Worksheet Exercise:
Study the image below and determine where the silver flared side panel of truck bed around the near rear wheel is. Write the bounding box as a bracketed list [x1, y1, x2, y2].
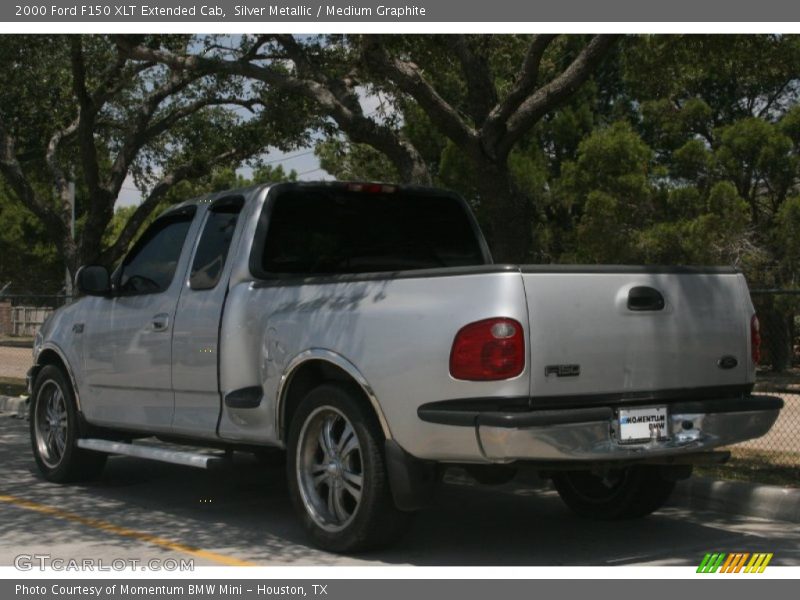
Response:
[220, 271, 529, 460]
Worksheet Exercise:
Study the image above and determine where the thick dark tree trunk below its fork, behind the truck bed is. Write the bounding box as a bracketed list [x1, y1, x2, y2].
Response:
[477, 164, 534, 263]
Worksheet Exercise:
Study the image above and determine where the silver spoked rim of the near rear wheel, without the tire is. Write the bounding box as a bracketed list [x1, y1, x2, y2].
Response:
[295, 406, 364, 531]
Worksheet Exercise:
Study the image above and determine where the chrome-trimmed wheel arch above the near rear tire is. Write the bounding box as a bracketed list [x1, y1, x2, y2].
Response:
[275, 348, 392, 442]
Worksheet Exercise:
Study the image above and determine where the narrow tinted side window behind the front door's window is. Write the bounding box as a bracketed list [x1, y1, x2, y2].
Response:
[189, 198, 242, 290]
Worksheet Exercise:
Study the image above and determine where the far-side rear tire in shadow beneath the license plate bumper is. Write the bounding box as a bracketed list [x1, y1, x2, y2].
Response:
[553, 465, 675, 520]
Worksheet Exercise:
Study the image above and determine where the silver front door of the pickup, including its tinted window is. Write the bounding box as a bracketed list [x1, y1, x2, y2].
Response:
[83, 206, 196, 432]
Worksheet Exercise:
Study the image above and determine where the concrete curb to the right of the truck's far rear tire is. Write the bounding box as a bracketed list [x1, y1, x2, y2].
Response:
[670, 477, 800, 523]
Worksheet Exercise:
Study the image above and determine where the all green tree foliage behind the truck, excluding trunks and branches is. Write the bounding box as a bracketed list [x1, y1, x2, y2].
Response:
[0, 35, 800, 308]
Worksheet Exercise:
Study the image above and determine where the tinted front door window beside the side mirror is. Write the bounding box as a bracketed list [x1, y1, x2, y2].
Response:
[119, 212, 194, 294]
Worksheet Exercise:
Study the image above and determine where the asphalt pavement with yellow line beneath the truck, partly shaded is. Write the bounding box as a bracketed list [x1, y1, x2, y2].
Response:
[0, 415, 800, 566]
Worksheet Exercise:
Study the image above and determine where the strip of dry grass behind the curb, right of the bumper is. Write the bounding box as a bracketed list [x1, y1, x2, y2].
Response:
[694, 448, 800, 487]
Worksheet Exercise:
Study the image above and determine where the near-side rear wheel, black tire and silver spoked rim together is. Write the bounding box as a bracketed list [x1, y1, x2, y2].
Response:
[287, 383, 409, 553]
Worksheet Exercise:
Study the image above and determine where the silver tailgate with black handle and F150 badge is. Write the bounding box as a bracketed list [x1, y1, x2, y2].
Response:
[522, 267, 754, 406]
